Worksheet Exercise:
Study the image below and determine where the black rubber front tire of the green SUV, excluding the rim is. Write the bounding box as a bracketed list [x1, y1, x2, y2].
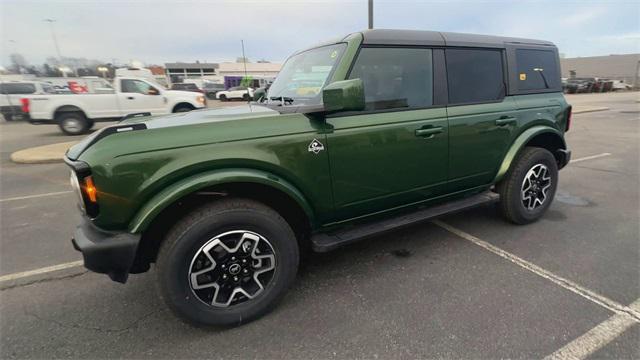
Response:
[156, 198, 299, 326]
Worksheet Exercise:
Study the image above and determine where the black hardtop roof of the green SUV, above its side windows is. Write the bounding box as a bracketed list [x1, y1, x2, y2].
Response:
[362, 29, 555, 48]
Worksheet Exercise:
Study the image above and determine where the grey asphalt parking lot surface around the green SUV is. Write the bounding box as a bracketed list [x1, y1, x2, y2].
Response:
[0, 93, 640, 359]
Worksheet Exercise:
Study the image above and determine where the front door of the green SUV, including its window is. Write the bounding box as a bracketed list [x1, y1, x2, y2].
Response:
[326, 47, 448, 221]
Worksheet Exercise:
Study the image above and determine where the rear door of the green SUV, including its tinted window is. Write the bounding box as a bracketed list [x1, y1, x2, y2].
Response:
[445, 48, 518, 192]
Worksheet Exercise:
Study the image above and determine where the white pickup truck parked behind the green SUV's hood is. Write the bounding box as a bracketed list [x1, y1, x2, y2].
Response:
[26, 77, 206, 135]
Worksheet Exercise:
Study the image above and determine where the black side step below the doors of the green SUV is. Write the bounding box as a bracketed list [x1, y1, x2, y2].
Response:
[311, 191, 500, 252]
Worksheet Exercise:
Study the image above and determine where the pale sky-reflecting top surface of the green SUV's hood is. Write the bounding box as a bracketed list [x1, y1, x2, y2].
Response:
[66, 104, 279, 160]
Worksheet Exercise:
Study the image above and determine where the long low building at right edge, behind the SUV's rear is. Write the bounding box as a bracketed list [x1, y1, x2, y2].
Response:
[560, 54, 640, 87]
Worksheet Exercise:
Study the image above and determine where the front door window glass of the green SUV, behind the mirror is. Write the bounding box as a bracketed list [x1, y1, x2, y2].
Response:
[349, 48, 433, 110]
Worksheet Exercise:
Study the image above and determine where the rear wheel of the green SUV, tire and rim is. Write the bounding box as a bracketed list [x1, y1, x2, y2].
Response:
[497, 147, 558, 224]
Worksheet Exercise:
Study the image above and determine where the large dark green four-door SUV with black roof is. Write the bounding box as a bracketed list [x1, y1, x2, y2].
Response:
[66, 30, 571, 325]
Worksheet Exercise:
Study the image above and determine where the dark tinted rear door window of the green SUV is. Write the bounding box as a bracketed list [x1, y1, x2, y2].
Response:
[445, 49, 505, 104]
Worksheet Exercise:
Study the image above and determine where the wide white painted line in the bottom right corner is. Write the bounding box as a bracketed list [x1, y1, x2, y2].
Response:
[544, 299, 640, 360]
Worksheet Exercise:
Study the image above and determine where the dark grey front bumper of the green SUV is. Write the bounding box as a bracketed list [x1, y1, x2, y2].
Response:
[71, 217, 140, 283]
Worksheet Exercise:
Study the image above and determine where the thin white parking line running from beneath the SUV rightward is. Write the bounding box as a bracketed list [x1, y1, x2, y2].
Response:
[433, 220, 640, 322]
